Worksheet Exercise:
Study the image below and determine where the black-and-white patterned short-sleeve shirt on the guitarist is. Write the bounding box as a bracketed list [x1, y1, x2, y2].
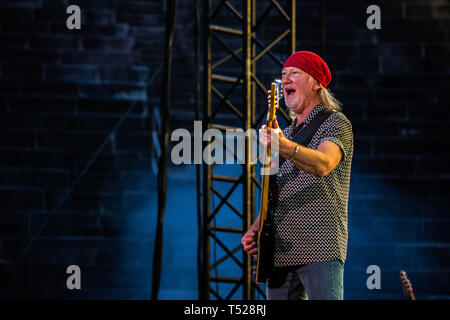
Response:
[273, 105, 353, 267]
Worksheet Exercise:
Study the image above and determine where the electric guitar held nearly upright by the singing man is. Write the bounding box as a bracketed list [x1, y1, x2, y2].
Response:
[256, 80, 281, 283]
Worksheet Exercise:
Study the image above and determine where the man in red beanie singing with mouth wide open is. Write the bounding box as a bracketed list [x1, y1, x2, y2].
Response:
[241, 51, 353, 300]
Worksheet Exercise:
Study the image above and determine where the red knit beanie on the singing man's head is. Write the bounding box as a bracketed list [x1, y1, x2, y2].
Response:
[283, 51, 331, 88]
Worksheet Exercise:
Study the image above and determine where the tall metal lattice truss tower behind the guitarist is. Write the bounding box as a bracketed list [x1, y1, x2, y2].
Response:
[198, 0, 295, 300]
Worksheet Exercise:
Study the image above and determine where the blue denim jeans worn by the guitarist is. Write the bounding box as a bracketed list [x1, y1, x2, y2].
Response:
[267, 260, 344, 300]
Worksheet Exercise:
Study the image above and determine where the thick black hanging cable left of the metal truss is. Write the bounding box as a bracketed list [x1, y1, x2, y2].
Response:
[152, 0, 176, 300]
